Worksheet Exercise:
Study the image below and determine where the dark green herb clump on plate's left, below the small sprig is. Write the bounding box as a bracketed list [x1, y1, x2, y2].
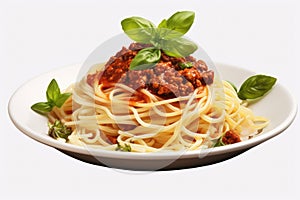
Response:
[48, 120, 72, 141]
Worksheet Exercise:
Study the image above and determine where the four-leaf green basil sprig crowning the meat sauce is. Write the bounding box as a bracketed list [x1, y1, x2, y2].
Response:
[121, 11, 198, 70]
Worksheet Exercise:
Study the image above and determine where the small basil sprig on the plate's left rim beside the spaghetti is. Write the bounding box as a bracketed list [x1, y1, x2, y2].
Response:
[31, 79, 71, 115]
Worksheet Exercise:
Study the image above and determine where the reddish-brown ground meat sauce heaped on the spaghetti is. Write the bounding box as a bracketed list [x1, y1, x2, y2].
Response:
[87, 43, 214, 99]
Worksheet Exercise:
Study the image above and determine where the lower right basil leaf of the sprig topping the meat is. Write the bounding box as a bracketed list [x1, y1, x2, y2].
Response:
[162, 38, 198, 57]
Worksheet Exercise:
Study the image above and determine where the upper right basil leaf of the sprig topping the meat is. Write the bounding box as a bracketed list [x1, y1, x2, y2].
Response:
[158, 11, 195, 40]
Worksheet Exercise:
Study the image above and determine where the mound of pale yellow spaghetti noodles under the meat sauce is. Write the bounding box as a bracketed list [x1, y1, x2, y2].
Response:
[49, 67, 268, 152]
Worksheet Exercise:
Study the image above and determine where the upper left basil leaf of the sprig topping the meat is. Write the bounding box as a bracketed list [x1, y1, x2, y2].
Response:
[121, 17, 156, 43]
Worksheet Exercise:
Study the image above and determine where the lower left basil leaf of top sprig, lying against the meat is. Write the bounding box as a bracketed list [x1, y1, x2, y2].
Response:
[130, 47, 161, 70]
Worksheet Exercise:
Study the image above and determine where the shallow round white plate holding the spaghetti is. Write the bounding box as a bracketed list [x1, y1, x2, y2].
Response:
[8, 64, 297, 170]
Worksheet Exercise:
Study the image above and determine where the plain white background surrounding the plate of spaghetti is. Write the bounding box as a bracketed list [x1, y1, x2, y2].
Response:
[0, 0, 300, 200]
